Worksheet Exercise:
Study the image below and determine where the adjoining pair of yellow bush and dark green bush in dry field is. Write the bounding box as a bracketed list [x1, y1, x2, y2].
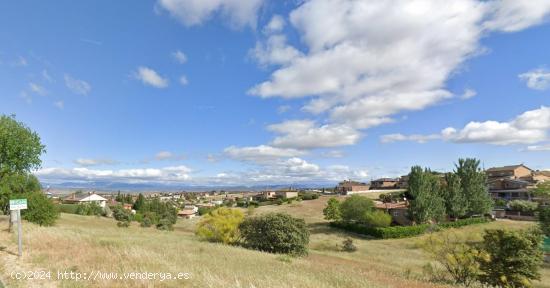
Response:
[196, 207, 309, 255]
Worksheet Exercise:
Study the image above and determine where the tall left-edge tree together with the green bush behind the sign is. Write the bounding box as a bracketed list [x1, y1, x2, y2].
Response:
[0, 115, 59, 230]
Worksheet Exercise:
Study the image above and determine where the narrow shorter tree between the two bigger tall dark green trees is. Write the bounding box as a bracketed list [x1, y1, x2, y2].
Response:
[442, 173, 468, 219]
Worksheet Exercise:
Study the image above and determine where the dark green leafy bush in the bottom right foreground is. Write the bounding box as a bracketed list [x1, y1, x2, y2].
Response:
[478, 229, 543, 287]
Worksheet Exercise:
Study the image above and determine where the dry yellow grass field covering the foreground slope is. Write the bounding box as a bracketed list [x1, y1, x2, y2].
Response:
[0, 197, 550, 287]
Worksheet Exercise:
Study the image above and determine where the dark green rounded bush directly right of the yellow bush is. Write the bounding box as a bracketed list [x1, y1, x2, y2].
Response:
[239, 213, 309, 255]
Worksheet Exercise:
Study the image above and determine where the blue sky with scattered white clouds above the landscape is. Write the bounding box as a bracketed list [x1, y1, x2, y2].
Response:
[0, 0, 550, 185]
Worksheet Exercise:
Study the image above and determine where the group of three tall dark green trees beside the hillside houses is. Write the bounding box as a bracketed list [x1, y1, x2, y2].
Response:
[406, 158, 493, 224]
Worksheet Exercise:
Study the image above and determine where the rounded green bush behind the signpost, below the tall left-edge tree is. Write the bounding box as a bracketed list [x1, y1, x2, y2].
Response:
[13, 191, 59, 226]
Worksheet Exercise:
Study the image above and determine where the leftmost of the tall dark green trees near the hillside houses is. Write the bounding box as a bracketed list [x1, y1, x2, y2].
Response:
[407, 166, 445, 224]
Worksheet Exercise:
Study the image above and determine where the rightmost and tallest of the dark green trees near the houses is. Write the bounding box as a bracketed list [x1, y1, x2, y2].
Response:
[455, 158, 493, 215]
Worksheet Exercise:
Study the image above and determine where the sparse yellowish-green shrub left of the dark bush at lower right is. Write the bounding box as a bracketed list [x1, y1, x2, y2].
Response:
[422, 232, 479, 287]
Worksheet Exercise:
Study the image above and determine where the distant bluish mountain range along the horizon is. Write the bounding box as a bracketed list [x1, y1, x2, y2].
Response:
[42, 181, 336, 192]
